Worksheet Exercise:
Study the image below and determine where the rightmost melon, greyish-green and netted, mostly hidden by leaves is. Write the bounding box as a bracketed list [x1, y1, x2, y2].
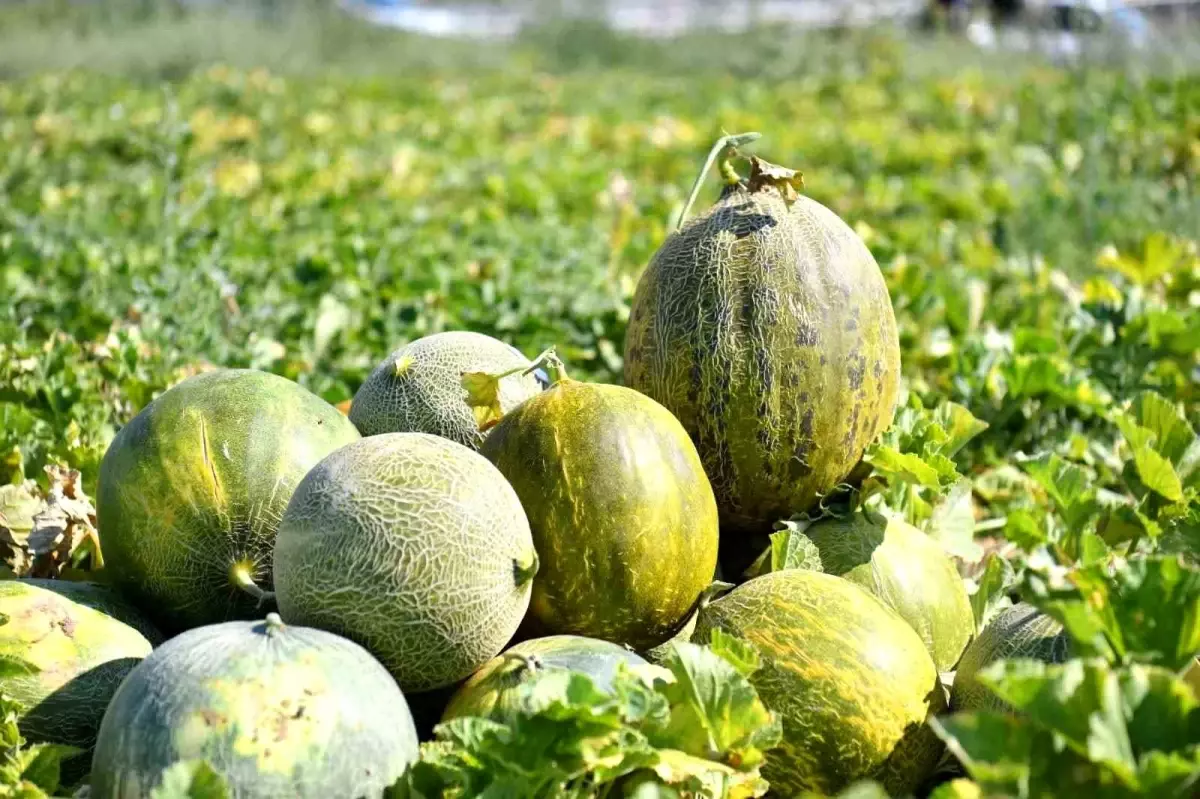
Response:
[950, 602, 1070, 711]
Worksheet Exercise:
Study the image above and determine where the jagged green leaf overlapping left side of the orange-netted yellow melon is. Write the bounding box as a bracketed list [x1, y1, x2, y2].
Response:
[650, 642, 781, 768]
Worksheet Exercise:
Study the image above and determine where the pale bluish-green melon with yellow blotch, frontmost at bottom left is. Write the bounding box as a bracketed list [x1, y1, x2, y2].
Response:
[90, 613, 418, 799]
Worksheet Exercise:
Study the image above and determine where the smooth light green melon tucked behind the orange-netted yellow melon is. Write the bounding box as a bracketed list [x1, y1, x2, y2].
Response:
[804, 512, 974, 672]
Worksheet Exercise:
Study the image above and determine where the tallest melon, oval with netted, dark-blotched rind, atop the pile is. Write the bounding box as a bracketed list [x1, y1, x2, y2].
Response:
[624, 188, 900, 535]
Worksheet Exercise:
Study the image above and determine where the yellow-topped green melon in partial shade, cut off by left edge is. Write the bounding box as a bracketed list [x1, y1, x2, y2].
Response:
[0, 578, 162, 750]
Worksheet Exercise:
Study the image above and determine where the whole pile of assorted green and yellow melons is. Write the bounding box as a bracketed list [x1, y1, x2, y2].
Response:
[0, 133, 993, 799]
